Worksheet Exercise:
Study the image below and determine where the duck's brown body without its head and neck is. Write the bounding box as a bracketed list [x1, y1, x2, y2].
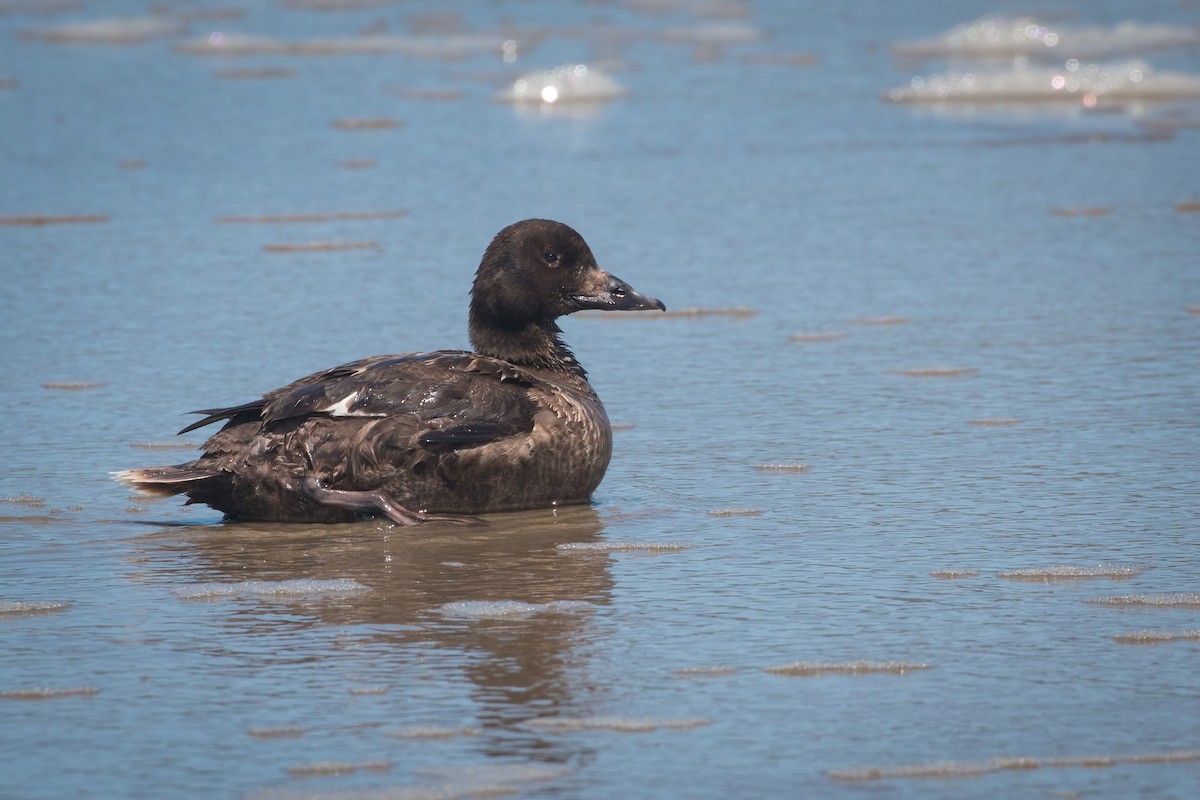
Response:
[142, 350, 612, 522]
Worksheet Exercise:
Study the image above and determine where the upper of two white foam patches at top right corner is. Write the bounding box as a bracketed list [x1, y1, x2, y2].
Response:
[892, 17, 1200, 59]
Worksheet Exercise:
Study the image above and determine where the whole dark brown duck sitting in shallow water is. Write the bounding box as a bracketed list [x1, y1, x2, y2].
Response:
[113, 219, 666, 525]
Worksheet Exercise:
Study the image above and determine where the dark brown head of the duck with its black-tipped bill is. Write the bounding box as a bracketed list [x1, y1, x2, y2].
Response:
[470, 219, 666, 331]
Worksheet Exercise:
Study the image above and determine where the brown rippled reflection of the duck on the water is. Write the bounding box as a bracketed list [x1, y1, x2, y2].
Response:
[138, 506, 612, 756]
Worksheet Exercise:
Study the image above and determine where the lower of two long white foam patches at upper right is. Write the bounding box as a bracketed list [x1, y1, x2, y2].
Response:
[884, 59, 1200, 108]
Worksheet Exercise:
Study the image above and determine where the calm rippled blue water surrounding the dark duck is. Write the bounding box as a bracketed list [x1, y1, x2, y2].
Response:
[0, 0, 1200, 799]
